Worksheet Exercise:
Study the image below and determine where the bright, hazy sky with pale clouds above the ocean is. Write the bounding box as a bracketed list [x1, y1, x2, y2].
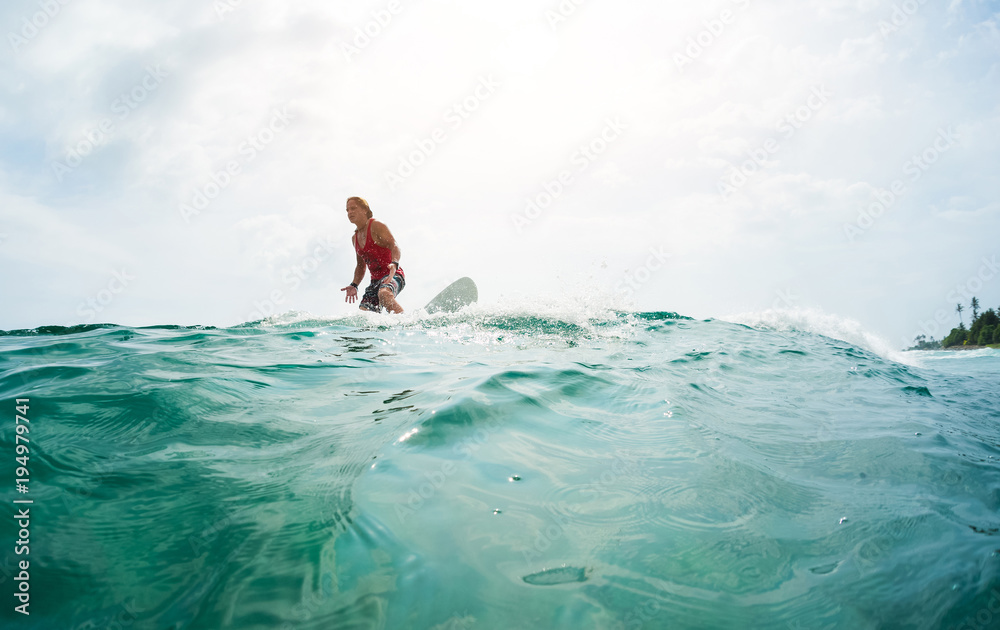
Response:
[0, 0, 1000, 345]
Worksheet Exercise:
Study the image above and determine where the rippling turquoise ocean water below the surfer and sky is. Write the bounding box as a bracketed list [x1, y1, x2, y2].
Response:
[0, 308, 1000, 630]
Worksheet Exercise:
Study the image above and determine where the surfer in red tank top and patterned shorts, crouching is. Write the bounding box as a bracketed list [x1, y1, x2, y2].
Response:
[341, 197, 406, 313]
